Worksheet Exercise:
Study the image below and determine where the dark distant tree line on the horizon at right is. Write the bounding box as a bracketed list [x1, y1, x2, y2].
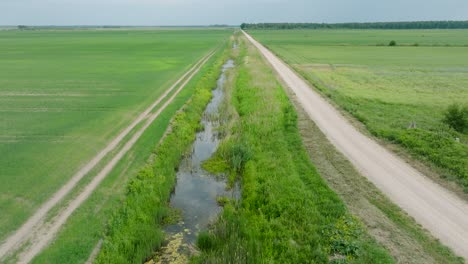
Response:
[241, 20, 468, 29]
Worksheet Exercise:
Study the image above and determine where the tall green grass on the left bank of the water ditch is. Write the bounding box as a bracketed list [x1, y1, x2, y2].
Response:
[96, 41, 227, 263]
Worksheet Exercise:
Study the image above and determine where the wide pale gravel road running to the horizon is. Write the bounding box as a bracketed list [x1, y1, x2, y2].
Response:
[244, 29, 468, 259]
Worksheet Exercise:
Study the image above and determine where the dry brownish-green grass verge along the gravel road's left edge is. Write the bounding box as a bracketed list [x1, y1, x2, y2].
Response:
[287, 80, 464, 264]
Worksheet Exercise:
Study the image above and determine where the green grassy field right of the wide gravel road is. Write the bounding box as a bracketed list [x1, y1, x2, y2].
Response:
[249, 30, 468, 191]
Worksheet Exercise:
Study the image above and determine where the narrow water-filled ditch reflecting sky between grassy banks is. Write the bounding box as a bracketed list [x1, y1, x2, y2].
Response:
[153, 60, 239, 263]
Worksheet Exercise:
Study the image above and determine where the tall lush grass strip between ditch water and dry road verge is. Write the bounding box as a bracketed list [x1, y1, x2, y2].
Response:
[192, 34, 394, 263]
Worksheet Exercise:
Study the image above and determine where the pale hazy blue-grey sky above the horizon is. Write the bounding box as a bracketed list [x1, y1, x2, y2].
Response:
[0, 0, 468, 25]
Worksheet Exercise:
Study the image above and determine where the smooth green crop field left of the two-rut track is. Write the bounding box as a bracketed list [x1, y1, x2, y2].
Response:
[0, 29, 230, 240]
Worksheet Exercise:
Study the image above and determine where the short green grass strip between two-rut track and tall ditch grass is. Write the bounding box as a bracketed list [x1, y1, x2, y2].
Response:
[33, 52, 225, 263]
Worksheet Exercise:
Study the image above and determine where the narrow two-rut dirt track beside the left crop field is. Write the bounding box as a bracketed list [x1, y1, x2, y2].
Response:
[0, 52, 213, 263]
